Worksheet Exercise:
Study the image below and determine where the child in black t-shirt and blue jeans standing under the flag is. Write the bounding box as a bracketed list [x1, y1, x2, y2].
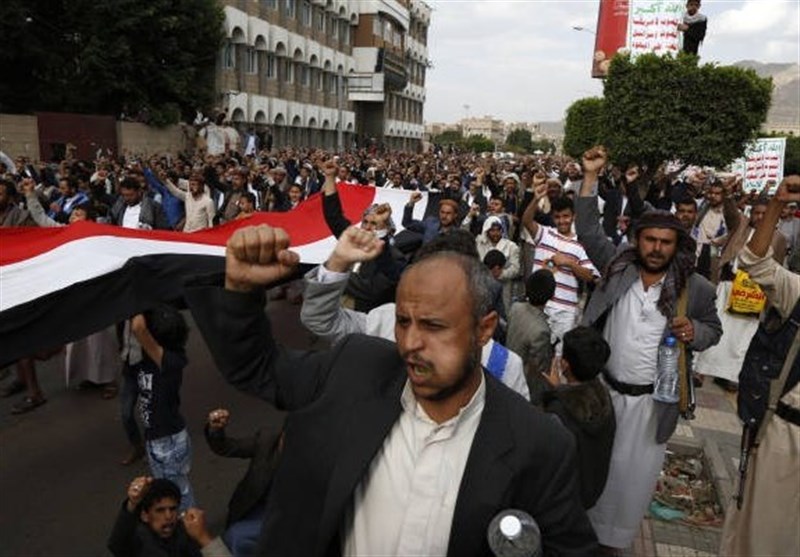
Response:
[131, 305, 194, 510]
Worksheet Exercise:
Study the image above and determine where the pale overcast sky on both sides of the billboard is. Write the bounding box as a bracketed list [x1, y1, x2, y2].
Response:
[424, 0, 800, 123]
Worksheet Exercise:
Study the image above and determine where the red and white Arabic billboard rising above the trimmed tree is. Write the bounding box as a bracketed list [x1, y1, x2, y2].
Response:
[592, 0, 685, 77]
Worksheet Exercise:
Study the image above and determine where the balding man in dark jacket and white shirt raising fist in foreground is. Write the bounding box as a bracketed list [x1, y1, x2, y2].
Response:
[186, 226, 597, 557]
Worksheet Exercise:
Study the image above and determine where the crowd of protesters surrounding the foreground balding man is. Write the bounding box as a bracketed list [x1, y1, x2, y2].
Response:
[0, 136, 800, 555]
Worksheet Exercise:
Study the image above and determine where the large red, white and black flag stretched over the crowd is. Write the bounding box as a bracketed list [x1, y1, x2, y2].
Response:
[0, 184, 434, 365]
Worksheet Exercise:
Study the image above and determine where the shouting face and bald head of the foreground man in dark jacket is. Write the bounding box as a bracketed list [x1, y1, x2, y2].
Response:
[394, 259, 491, 402]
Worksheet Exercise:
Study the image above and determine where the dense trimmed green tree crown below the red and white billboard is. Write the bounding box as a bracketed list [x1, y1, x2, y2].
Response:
[564, 54, 772, 170]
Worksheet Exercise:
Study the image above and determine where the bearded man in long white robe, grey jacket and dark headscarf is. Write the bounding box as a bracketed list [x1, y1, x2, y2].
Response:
[575, 147, 722, 554]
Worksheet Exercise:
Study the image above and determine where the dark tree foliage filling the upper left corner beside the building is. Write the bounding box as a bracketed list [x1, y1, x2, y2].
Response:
[0, 0, 224, 124]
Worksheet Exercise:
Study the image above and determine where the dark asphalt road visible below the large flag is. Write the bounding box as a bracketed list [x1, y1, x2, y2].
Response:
[0, 302, 314, 557]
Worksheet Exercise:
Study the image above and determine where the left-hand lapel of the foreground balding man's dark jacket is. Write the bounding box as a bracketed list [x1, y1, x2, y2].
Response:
[315, 373, 406, 555]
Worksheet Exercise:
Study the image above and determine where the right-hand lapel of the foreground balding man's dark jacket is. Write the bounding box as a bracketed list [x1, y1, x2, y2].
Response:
[447, 373, 514, 555]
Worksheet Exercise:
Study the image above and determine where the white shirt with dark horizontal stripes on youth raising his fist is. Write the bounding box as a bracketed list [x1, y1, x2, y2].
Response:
[533, 224, 600, 311]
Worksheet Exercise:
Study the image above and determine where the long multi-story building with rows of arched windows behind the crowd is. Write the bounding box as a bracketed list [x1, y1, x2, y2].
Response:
[216, 0, 431, 149]
